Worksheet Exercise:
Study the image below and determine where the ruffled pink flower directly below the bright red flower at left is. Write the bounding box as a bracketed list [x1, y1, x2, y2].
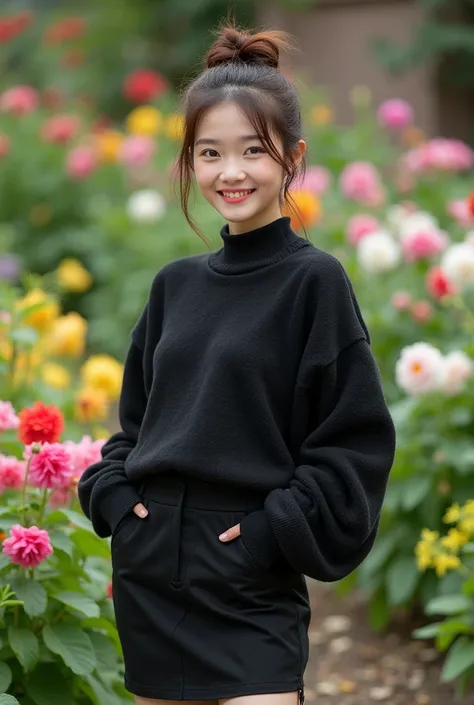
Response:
[25, 442, 72, 489]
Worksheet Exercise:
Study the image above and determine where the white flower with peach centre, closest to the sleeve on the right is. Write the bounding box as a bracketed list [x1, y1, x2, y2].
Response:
[395, 343, 445, 396]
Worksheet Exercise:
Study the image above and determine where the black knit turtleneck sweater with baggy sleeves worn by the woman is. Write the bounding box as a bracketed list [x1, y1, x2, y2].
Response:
[78, 217, 395, 582]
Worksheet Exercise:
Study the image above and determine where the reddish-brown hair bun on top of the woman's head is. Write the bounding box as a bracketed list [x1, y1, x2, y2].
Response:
[206, 25, 291, 70]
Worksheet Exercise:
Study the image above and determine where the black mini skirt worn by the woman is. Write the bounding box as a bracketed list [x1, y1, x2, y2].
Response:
[111, 473, 311, 705]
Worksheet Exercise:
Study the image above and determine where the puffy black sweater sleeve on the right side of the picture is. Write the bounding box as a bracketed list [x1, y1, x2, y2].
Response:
[241, 256, 395, 582]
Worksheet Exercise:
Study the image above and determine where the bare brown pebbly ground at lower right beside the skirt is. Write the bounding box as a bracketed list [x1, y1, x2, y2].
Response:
[305, 580, 474, 705]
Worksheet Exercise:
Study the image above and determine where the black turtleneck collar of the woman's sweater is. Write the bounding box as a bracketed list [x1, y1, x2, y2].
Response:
[209, 216, 310, 274]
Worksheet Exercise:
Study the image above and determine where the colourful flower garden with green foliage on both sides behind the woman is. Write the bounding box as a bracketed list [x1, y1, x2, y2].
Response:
[0, 5, 474, 705]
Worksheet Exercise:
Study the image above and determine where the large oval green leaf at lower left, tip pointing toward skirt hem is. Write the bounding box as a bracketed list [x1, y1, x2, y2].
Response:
[43, 624, 97, 676]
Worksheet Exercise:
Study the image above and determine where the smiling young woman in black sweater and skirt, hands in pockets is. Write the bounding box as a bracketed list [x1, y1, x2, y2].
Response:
[79, 19, 395, 705]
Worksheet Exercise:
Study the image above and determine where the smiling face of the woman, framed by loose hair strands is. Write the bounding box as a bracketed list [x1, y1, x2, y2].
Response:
[193, 103, 296, 234]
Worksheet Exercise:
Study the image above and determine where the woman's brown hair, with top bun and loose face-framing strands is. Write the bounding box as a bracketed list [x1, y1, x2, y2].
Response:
[177, 21, 305, 242]
